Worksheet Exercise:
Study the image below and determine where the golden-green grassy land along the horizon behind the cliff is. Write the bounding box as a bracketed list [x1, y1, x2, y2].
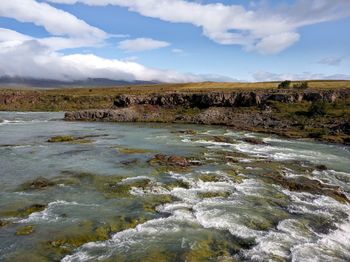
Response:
[0, 81, 350, 111]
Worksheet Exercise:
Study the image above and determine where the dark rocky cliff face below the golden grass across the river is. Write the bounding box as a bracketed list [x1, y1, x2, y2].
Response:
[114, 89, 350, 109]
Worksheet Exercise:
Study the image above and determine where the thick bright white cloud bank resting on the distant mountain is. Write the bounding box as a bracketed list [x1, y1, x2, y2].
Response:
[0, 36, 232, 82]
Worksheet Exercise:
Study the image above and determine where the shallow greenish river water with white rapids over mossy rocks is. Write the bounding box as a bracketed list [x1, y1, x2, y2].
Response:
[0, 112, 350, 261]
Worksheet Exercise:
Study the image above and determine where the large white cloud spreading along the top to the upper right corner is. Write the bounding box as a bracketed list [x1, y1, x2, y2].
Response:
[48, 0, 350, 54]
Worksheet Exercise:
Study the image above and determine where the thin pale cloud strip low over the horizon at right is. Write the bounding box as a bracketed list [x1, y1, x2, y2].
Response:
[253, 71, 350, 82]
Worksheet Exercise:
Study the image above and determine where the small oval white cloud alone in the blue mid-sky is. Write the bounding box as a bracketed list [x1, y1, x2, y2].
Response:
[118, 38, 170, 52]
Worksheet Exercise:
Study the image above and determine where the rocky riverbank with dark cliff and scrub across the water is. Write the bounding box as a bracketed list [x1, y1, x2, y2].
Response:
[65, 89, 350, 144]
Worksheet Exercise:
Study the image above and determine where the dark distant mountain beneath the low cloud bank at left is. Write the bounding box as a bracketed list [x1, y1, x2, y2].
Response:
[0, 76, 159, 88]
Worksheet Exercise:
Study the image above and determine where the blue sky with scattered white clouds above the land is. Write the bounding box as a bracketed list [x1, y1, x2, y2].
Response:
[0, 0, 350, 82]
